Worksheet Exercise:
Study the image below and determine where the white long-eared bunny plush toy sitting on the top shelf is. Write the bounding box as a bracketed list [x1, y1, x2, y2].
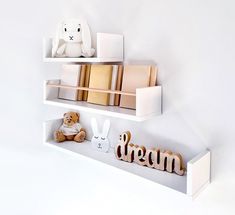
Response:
[52, 19, 95, 57]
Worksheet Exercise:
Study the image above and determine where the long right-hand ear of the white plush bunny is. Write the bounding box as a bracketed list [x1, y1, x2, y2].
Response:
[81, 20, 92, 55]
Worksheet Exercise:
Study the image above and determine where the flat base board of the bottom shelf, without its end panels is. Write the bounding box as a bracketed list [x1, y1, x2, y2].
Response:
[46, 141, 186, 193]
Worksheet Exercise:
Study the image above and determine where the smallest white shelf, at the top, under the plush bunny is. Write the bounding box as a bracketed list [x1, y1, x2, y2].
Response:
[43, 33, 123, 63]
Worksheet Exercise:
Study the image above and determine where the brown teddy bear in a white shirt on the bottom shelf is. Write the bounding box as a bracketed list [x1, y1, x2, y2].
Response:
[54, 112, 86, 143]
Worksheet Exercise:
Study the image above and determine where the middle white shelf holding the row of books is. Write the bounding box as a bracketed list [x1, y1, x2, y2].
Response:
[44, 80, 161, 121]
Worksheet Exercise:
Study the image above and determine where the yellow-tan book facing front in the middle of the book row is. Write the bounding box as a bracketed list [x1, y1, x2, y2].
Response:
[87, 65, 113, 105]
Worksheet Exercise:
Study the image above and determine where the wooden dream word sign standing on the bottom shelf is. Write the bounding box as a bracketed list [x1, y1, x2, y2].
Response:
[115, 131, 185, 175]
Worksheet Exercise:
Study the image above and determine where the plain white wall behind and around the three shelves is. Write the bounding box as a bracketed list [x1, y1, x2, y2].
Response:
[0, 0, 235, 215]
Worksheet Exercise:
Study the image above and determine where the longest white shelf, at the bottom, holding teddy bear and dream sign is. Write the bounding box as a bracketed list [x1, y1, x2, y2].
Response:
[44, 119, 210, 197]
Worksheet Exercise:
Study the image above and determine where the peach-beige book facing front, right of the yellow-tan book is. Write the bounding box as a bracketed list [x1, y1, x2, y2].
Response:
[120, 65, 151, 109]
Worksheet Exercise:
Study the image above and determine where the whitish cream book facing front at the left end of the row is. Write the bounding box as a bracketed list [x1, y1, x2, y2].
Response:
[59, 64, 81, 101]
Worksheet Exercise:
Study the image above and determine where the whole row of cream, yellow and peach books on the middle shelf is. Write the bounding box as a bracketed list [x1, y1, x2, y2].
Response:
[59, 64, 157, 109]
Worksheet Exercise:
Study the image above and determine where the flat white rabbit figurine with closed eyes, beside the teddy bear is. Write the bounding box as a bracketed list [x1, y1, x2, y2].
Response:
[91, 118, 110, 152]
